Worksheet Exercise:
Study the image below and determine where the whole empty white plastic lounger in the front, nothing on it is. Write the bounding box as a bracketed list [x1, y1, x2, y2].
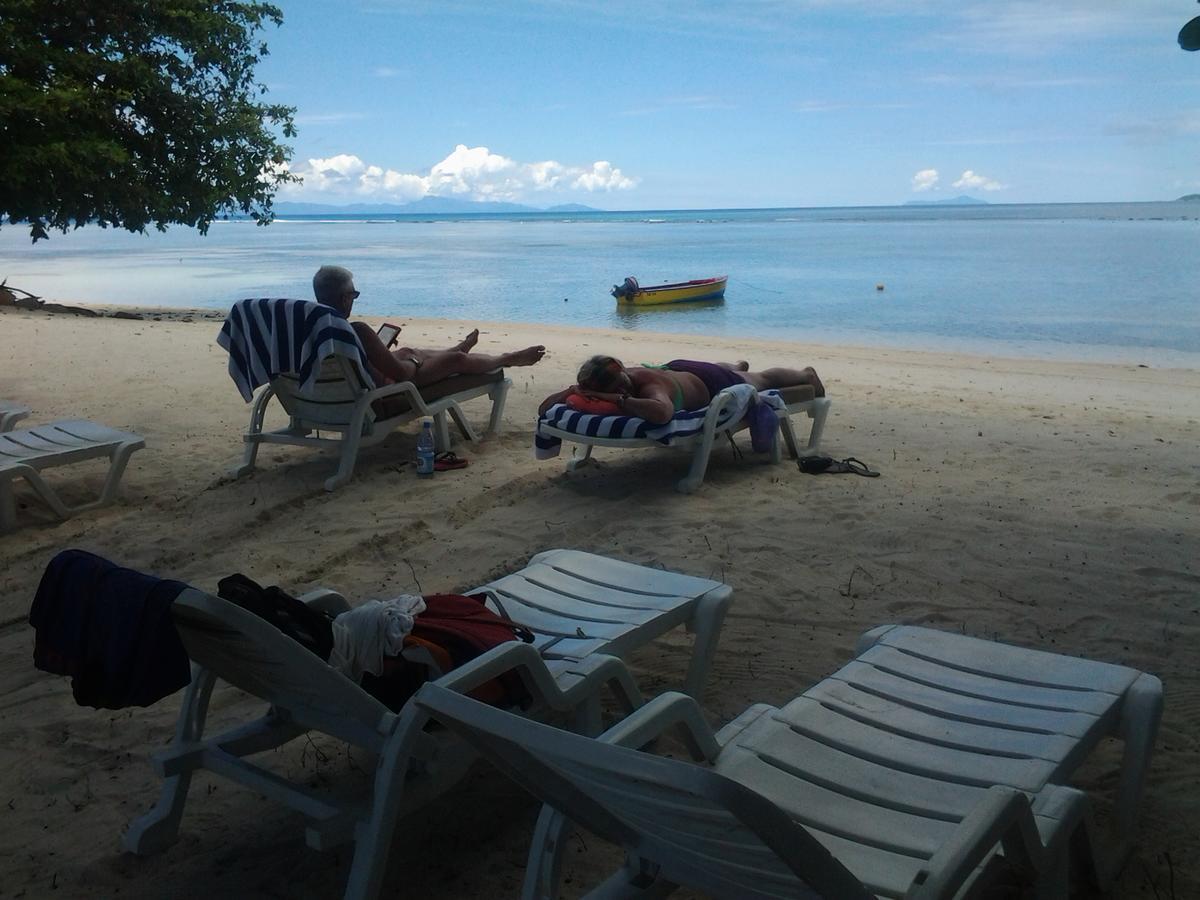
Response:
[415, 626, 1162, 898]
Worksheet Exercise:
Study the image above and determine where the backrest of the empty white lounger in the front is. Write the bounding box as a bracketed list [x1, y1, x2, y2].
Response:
[415, 684, 869, 900]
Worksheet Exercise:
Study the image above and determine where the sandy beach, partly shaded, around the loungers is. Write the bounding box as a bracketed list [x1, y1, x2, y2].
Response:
[0, 308, 1200, 900]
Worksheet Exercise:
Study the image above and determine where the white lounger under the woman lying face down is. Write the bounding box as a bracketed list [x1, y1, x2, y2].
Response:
[536, 385, 832, 493]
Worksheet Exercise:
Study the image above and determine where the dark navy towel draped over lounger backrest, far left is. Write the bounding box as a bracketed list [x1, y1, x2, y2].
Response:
[29, 550, 192, 709]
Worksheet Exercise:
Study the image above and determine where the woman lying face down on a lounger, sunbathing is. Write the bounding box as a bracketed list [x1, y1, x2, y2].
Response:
[538, 356, 824, 425]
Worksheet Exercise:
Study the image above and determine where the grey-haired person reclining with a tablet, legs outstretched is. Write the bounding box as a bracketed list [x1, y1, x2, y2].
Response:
[312, 265, 546, 388]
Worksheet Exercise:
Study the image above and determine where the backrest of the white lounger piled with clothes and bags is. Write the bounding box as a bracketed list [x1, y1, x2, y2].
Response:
[172, 588, 394, 746]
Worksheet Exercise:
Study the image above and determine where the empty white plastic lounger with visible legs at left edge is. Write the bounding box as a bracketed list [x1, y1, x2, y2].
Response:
[0, 419, 145, 534]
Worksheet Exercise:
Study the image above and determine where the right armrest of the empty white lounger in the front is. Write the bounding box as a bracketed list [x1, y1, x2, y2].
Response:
[906, 785, 1060, 898]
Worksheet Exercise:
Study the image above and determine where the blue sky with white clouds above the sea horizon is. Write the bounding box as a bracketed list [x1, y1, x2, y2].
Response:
[258, 0, 1200, 210]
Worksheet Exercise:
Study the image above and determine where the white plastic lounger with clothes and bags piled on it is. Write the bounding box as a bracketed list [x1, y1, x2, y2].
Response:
[121, 550, 732, 899]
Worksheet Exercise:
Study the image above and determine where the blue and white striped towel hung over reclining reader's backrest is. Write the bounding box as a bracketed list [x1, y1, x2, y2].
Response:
[217, 298, 374, 403]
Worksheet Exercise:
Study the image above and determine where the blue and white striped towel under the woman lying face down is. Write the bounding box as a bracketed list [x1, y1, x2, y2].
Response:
[533, 384, 784, 460]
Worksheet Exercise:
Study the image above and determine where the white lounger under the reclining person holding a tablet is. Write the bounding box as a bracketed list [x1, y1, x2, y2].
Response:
[233, 356, 512, 491]
